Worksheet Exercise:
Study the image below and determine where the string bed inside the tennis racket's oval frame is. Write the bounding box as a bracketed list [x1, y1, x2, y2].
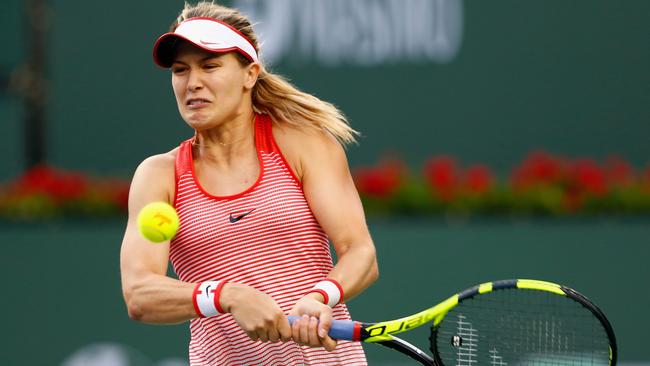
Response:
[431, 289, 609, 366]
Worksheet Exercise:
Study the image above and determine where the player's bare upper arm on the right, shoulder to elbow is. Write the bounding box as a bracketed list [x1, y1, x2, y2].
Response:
[279, 126, 374, 257]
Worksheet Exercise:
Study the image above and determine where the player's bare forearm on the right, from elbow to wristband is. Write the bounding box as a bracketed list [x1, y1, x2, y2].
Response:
[328, 244, 379, 301]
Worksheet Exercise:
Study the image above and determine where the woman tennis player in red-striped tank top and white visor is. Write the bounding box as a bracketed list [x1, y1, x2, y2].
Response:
[121, 2, 378, 366]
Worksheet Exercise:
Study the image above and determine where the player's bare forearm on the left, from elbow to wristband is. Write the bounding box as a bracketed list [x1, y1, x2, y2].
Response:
[124, 273, 198, 324]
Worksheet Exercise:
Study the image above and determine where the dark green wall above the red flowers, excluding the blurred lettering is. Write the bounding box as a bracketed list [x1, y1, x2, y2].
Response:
[0, 0, 650, 179]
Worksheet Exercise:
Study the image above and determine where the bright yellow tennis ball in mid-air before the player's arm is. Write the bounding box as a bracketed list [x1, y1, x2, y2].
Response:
[138, 202, 179, 243]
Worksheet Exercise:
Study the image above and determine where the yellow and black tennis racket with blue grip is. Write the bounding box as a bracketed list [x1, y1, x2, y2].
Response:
[290, 280, 616, 366]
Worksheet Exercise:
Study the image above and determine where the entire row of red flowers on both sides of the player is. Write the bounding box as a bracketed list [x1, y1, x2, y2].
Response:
[5, 151, 650, 220]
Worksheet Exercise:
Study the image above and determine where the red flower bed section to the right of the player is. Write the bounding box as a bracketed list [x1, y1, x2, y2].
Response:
[353, 151, 650, 215]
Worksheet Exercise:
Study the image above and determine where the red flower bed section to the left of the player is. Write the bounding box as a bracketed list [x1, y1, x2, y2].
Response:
[0, 165, 129, 219]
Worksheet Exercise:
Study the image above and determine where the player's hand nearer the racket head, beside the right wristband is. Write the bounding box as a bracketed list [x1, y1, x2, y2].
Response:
[289, 293, 337, 351]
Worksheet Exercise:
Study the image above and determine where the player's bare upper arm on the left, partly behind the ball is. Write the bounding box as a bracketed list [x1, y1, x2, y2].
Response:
[120, 154, 175, 294]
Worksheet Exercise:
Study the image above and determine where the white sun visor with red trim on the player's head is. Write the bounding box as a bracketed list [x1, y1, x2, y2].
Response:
[153, 18, 258, 68]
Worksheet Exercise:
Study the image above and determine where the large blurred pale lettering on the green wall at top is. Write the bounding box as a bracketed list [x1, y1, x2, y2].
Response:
[233, 0, 463, 66]
